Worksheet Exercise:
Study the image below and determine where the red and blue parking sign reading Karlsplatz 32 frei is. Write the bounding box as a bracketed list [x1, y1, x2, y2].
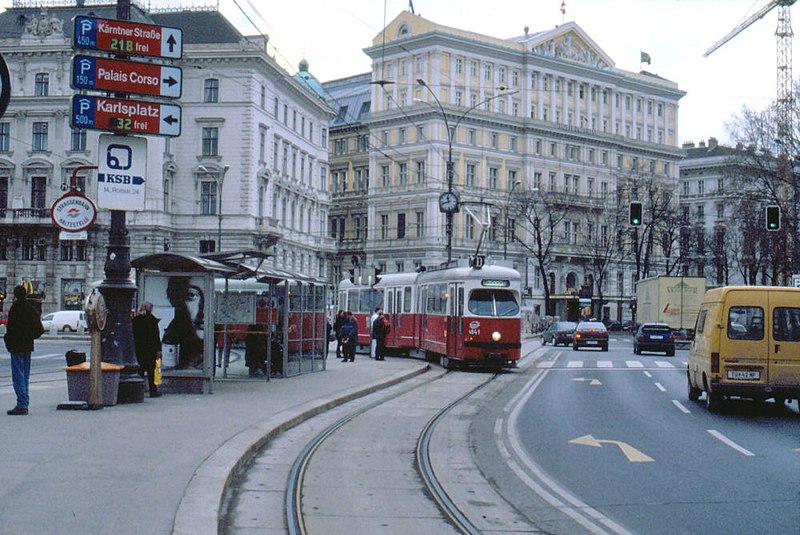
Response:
[71, 95, 181, 137]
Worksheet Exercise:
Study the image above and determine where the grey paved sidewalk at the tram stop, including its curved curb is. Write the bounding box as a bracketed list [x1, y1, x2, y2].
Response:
[0, 355, 427, 535]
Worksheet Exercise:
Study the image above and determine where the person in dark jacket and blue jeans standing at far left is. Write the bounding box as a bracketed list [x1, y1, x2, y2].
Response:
[3, 284, 44, 416]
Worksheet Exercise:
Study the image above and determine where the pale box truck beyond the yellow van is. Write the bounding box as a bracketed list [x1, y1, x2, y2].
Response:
[636, 275, 706, 336]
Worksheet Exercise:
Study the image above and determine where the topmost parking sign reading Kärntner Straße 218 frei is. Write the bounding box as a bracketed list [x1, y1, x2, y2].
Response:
[72, 16, 183, 59]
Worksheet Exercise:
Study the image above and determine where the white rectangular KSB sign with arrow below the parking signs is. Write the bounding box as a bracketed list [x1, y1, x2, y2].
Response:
[97, 134, 147, 210]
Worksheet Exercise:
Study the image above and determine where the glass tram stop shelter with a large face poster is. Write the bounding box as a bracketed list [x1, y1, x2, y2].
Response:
[131, 251, 328, 393]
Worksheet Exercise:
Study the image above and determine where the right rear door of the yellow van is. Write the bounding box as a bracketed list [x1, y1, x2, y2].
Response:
[769, 290, 800, 387]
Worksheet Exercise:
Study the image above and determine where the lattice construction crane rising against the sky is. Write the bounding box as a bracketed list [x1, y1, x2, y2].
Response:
[703, 0, 797, 152]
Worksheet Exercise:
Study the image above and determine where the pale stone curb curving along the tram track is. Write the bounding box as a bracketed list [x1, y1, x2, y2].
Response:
[172, 364, 430, 535]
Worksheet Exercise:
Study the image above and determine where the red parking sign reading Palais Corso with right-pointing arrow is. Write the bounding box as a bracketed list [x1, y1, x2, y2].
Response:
[72, 56, 183, 98]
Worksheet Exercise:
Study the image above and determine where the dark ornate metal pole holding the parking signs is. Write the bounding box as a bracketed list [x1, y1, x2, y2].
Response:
[99, 0, 144, 403]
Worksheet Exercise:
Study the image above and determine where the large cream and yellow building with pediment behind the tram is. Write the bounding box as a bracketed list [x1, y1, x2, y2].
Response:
[364, 12, 684, 319]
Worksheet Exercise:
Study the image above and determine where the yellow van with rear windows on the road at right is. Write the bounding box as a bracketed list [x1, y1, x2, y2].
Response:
[687, 286, 800, 411]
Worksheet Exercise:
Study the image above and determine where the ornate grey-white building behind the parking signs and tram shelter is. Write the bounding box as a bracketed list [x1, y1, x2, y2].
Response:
[0, 1, 334, 312]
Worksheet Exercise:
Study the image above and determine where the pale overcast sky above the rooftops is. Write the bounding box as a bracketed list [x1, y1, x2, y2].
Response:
[0, 0, 788, 147]
